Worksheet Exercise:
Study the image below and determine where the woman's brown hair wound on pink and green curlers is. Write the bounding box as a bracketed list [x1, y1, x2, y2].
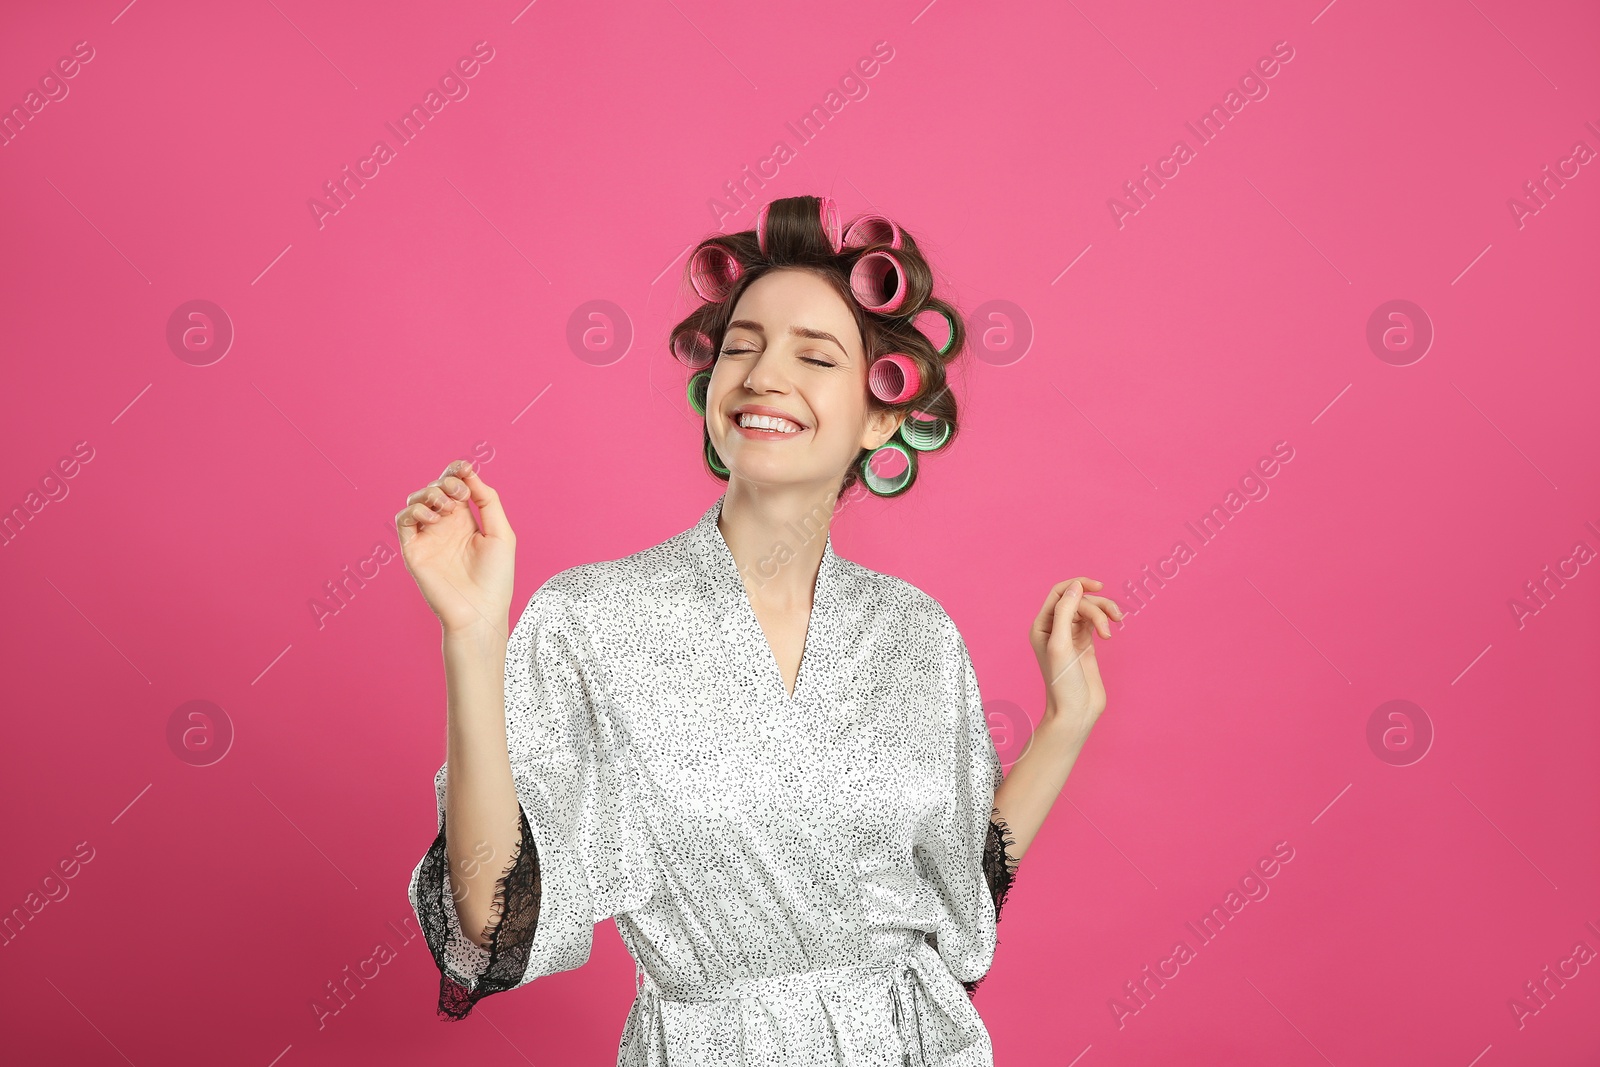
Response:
[669, 197, 966, 496]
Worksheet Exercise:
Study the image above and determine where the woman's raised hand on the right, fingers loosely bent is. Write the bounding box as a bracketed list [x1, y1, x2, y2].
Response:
[1029, 577, 1123, 741]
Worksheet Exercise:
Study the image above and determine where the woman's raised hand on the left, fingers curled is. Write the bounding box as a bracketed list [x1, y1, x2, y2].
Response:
[395, 459, 517, 638]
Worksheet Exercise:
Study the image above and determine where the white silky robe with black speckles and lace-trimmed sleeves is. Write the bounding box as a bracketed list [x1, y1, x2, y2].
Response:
[410, 496, 1014, 1067]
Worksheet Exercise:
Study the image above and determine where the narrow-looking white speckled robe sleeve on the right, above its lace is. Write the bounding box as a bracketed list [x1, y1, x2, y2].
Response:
[914, 616, 1016, 995]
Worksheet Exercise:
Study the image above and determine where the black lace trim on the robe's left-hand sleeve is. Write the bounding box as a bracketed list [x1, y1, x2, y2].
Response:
[418, 803, 542, 1021]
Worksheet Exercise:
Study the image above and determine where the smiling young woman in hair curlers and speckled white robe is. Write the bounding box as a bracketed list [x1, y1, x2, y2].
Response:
[395, 197, 1122, 1067]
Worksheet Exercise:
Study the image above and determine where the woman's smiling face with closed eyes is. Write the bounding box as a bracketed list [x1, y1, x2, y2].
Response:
[706, 270, 899, 490]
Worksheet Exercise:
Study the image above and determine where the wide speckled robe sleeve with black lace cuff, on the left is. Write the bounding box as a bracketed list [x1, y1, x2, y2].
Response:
[410, 571, 653, 1019]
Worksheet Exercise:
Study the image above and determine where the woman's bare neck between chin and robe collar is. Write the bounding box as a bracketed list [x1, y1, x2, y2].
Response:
[717, 482, 838, 608]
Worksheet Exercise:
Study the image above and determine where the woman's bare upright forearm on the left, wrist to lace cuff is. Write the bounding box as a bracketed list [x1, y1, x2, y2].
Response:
[442, 625, 520, 945]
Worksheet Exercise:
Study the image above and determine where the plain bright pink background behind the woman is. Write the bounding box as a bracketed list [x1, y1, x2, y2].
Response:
[0, 0, 1600, 1067]
